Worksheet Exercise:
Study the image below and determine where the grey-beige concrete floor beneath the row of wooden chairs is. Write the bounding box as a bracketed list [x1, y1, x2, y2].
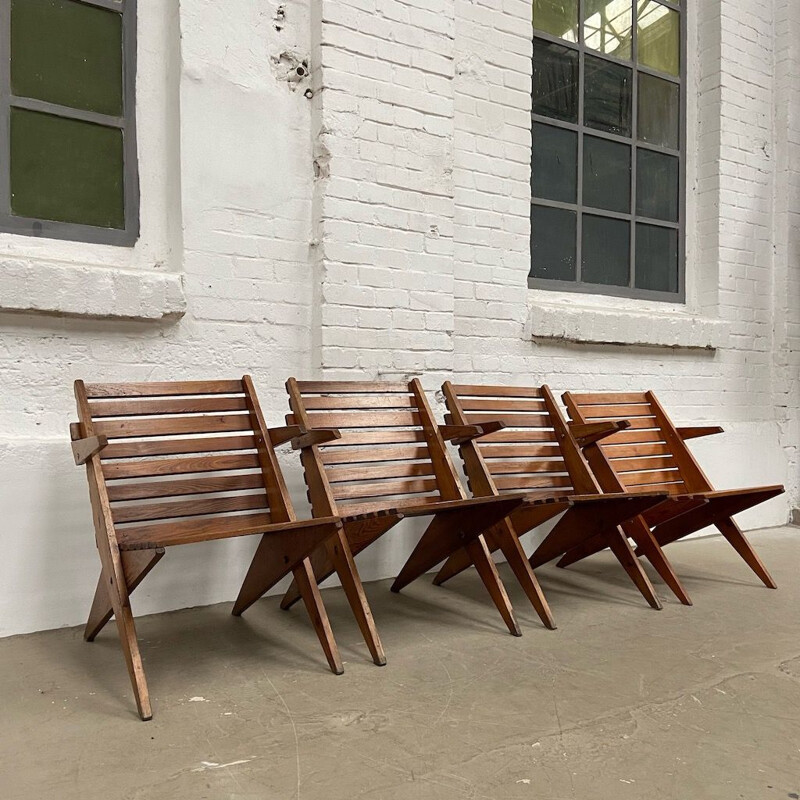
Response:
[0, 528, 800, 800]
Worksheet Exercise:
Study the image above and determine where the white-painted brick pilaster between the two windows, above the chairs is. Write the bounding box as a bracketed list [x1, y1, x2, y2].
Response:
[315, 0, 455, 377]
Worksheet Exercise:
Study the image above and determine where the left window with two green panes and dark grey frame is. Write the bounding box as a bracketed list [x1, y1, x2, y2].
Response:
[0, 0, 139, 245]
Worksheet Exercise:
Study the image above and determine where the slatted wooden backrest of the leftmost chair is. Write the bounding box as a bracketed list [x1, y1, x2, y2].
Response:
[73, 376, 295, 547]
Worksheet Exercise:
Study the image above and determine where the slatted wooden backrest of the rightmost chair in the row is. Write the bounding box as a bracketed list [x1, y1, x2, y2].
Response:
[563, 392, 712, 494]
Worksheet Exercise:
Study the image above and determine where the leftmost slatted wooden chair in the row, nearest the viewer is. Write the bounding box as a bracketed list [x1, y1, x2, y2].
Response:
[70, 376, 342, 720]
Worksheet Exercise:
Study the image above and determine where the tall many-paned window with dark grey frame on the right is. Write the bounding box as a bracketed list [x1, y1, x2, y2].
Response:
[529, 0, 686, 302]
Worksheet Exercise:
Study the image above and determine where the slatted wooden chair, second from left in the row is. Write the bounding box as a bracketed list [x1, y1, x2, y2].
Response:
[266, 378, 521, 663]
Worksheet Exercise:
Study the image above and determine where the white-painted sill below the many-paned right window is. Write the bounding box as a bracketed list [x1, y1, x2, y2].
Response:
[527, 293, 730, 351]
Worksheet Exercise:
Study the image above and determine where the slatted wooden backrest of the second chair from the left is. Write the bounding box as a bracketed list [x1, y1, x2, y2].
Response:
[286, 378, 465, 516]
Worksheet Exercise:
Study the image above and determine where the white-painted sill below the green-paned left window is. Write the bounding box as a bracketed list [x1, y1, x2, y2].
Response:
[0, 258, 186, 321]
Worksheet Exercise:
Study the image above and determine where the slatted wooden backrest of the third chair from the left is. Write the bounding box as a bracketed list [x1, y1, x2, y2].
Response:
[442, 381, 600, 497]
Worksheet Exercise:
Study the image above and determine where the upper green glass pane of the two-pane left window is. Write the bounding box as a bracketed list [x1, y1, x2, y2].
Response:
[11, 0, 122, 116]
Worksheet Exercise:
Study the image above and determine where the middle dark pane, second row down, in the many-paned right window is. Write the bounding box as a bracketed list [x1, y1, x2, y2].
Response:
[583, 56, 632, 136]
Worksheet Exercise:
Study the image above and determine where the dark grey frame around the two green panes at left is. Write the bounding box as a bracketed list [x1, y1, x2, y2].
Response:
[0, 0, 139, 247]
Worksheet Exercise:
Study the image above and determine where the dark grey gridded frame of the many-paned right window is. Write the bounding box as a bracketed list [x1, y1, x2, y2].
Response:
[528, 0, 688, 304]
